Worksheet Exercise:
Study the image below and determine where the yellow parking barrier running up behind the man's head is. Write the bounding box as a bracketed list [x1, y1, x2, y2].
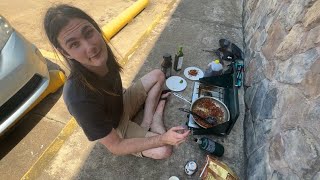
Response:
[101, 0, 149, 41]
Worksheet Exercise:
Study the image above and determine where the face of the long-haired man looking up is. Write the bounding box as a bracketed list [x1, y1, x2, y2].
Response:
[58, 18, 108, 67]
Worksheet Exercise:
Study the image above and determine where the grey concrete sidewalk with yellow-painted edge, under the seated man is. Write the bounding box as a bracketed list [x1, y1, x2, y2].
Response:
[24, 0, 245, 180]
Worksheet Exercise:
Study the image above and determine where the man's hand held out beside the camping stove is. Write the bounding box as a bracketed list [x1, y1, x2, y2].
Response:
[160, 126, 190, 146]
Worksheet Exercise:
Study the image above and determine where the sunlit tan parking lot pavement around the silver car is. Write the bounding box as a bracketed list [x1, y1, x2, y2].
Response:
[0, 0, 138, 179]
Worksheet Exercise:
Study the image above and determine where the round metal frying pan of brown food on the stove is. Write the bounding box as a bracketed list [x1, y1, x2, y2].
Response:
[190, 96, 230, 128]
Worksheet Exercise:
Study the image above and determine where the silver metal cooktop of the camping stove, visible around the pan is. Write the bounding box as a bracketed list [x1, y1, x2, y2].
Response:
[188, 82, 225, 128]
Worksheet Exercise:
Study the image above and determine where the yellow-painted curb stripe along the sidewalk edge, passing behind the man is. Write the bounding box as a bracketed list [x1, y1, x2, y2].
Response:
[21, 0, 177, 180]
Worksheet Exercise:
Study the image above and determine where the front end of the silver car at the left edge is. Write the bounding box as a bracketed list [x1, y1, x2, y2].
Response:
[0, 15, 50, 136]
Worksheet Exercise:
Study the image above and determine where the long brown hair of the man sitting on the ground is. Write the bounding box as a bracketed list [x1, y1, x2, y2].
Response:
[44, 4, 122, 96]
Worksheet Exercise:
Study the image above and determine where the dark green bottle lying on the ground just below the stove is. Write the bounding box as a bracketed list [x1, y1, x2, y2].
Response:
[194, 137, 224, 157]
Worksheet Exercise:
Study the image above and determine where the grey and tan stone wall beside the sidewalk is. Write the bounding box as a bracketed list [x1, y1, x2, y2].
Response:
[243, 0, 320, 180]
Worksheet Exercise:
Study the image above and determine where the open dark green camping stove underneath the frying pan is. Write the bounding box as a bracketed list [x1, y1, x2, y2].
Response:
[187, 63, 240, 136]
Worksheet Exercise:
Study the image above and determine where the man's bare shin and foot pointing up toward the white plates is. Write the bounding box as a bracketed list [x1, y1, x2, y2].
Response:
[150, 92, 171, 134]
